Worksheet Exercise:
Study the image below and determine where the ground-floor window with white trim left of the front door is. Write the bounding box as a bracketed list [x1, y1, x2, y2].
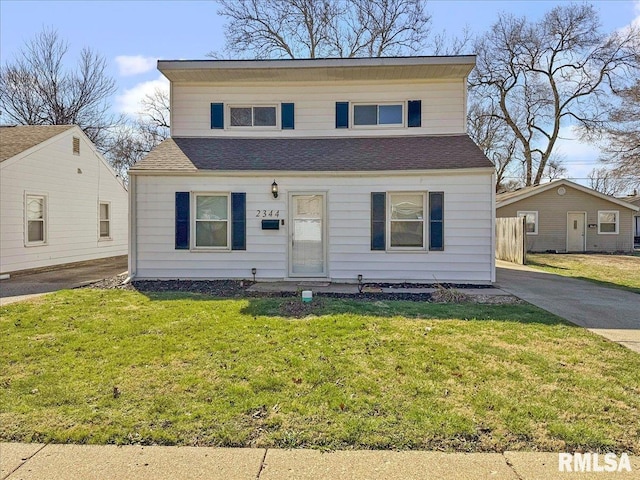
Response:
[193, 193, 230, 249]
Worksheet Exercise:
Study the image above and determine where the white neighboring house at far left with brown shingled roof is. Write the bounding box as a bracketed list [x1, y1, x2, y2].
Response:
[0, 125, 128, 274]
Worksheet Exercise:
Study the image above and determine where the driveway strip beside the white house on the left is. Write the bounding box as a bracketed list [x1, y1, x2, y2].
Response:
[0, 255, 127, 305]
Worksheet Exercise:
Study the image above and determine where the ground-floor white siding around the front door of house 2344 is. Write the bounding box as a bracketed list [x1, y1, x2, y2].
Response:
[132, 172, 493, 283]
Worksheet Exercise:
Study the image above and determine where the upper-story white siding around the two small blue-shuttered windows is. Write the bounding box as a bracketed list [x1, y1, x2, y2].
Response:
[171, 79, 466, 137]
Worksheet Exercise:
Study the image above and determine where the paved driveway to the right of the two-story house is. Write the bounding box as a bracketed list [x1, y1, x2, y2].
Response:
[496, 261, 640, 353]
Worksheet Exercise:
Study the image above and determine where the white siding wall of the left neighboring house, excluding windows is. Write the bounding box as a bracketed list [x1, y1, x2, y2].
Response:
[0, 128, 128, 273]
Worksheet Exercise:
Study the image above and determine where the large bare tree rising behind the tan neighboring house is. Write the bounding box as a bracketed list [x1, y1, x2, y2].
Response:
[470, 4, 638, 185]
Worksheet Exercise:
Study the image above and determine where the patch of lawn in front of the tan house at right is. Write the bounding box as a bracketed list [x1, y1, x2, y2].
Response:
[527, 253, 640, 293]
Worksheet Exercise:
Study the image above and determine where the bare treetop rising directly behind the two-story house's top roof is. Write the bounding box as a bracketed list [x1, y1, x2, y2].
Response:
[211, 0, 430, 58]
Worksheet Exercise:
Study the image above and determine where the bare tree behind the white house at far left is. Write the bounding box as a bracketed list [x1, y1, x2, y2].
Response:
[0, 30, 121, 149]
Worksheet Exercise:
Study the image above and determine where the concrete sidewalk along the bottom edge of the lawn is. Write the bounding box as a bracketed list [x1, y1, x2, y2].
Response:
[0, 443, 640, 480]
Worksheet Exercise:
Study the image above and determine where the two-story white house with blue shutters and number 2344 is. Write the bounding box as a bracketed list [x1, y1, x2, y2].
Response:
[129, 56, 495, 284]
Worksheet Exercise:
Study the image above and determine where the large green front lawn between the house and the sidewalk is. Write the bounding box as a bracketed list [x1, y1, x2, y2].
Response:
[0, 289, 640, 454]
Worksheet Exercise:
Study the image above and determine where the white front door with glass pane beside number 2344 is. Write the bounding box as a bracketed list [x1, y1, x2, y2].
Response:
[289, 193, 327, 277]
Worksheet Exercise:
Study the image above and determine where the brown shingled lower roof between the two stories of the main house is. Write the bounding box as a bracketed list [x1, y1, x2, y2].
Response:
[131, 135, 493, 173]
